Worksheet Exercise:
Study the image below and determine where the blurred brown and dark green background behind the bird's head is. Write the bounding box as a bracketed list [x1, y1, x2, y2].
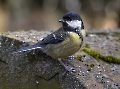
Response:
[0, 0, 120, 31]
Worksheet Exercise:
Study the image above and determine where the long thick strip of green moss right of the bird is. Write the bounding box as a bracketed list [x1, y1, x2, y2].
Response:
[82, 48, 120, 64]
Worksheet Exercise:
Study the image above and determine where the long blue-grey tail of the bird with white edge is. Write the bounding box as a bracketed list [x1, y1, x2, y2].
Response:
[12, 44, 43, 54]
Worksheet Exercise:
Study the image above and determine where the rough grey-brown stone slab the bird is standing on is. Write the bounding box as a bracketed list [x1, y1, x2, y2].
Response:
[0, 30, 120, 89]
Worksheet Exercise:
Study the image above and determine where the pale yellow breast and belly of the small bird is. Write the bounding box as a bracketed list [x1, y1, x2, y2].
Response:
[45, 32, 82, 59]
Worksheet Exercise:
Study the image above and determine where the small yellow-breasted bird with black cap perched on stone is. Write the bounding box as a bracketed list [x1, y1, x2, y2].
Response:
[13, 11, 85, 70]
